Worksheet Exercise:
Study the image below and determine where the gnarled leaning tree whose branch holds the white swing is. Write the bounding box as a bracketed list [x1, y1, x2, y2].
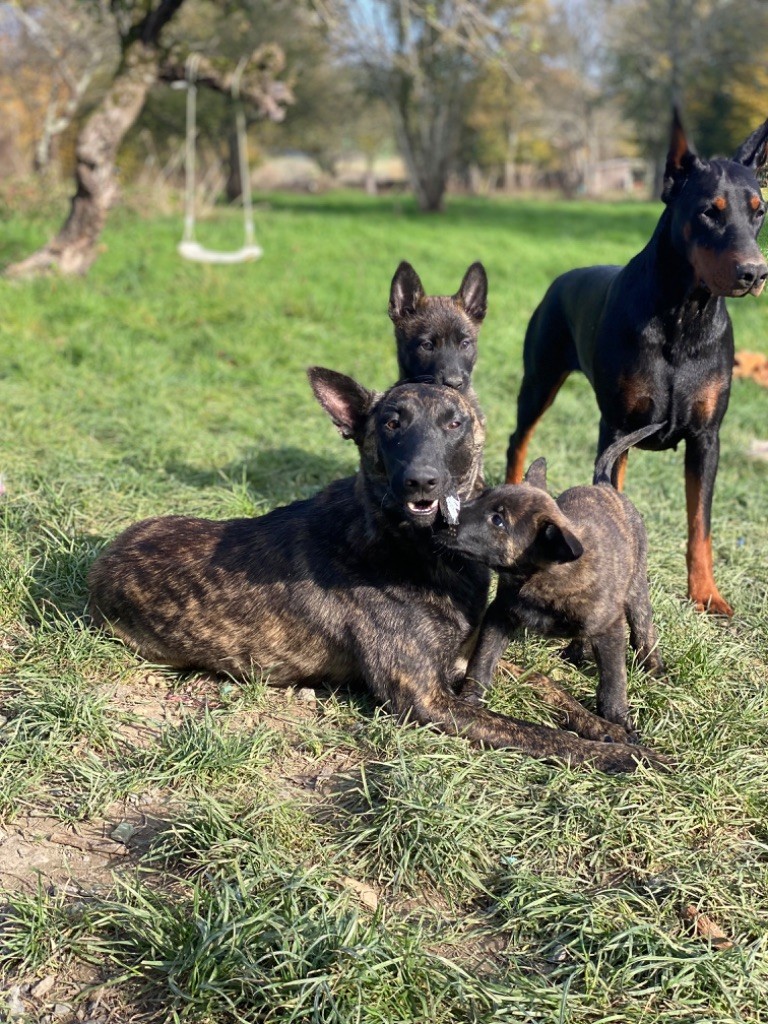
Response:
[6, 0, 292, 276]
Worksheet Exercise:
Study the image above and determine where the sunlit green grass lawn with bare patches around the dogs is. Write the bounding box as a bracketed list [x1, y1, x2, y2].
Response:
[0, 194, 768, 1024]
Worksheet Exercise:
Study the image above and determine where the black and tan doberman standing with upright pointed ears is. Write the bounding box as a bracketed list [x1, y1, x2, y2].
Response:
[507, 113, 768, 615]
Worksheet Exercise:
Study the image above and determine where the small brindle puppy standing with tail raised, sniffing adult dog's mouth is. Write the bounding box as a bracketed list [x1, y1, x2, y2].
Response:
[440, 424, 664, 732]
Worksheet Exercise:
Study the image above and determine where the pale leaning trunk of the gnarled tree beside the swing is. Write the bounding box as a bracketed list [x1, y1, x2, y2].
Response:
[5, 42, 159, 278]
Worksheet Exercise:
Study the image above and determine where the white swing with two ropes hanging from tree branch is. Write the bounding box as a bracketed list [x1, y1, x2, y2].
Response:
[177, 53, 263, 263]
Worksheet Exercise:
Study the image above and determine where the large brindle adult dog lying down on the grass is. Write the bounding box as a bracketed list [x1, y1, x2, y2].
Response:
[89, 369, 653, 771]
